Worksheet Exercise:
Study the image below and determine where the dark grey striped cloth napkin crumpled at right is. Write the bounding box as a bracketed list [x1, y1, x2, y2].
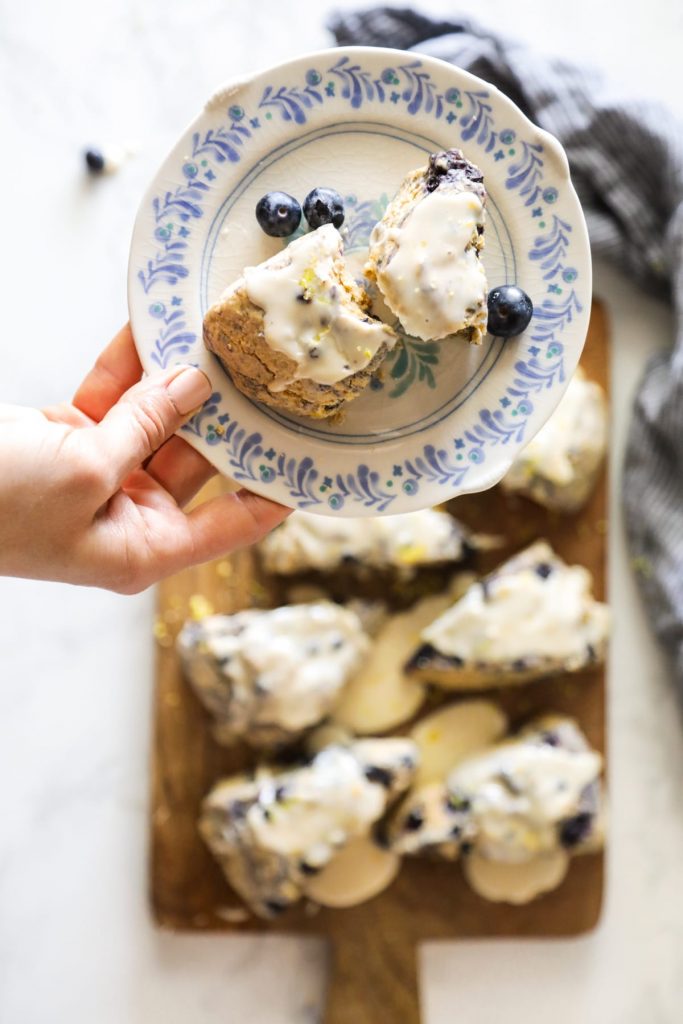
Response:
[330, 7, 683, 699]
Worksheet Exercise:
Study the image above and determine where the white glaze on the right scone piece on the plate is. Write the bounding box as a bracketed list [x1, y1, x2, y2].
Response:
[377, 188, 487, 341]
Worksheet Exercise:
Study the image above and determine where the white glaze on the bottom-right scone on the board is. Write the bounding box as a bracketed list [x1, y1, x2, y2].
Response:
[447, 737, 602, 862]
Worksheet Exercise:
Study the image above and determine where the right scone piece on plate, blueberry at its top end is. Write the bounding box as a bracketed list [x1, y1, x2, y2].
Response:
[365, 150, 488, 345]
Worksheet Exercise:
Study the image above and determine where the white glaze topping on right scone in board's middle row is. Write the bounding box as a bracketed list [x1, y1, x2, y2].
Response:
[413, 541, 608, 671]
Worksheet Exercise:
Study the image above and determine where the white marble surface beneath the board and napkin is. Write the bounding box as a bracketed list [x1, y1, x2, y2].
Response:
[0, 0, 683, 1024]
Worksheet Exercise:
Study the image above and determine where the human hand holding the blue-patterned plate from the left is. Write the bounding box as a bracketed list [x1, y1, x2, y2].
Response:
[0, 327, 290, 594]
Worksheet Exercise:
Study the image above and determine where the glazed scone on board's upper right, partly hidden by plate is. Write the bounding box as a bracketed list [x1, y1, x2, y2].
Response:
[501, 368, 607, 512]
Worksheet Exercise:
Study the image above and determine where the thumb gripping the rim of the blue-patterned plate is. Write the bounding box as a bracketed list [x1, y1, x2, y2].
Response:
[91, 366, 211, 486]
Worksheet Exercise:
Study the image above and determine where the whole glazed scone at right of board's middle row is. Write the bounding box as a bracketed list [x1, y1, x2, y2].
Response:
[407, 541, 609, 689]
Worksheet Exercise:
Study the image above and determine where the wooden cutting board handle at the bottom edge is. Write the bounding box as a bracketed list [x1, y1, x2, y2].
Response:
[323, 931, 420, 1024]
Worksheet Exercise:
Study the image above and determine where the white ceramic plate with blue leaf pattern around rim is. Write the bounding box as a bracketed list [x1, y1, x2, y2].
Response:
[129, 47, 591, 516]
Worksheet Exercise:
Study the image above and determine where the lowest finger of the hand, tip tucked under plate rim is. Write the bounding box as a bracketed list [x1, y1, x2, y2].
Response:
[180, 490, 292, 568]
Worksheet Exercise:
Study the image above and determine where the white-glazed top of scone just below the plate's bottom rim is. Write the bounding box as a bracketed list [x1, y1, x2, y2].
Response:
[260, 509, 476, 575]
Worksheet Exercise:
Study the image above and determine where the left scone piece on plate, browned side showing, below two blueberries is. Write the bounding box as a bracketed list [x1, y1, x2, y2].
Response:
[204, 224, 396, 419]
